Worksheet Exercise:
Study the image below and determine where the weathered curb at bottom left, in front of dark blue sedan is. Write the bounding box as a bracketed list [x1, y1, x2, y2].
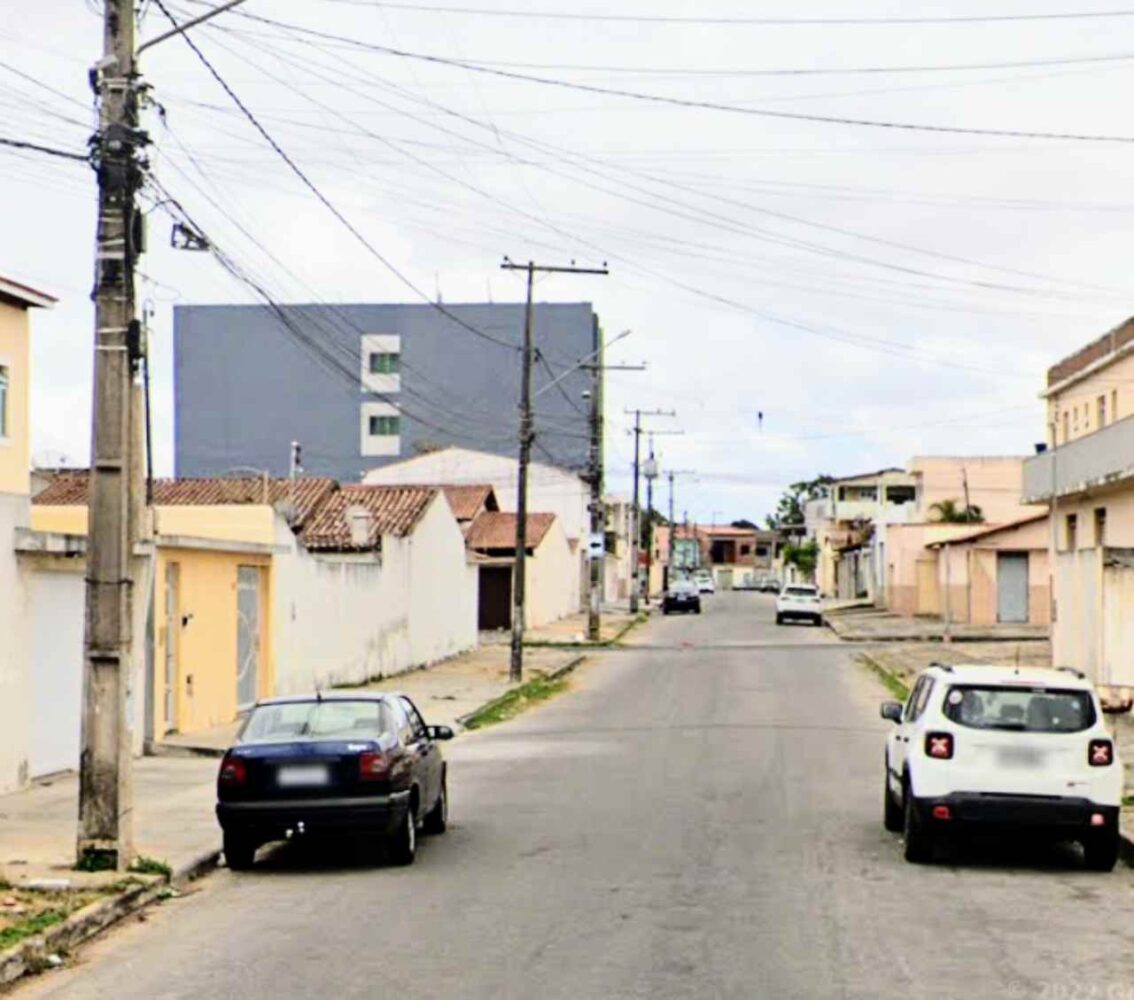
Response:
[0, 849, 220, 986]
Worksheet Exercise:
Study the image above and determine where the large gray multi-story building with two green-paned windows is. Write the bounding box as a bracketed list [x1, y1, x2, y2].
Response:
[174, 303, 601, 482]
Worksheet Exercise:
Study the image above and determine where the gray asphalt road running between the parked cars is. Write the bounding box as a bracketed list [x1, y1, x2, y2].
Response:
[19, 594, 1134, 1000]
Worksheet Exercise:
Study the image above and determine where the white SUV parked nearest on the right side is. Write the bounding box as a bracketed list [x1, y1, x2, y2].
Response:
[882, 663, 1123, 872]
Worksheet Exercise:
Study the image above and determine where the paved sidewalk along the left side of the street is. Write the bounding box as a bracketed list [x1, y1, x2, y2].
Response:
[0, 630, 603, 986]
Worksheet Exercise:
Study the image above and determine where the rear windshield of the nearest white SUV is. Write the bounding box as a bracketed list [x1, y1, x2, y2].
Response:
[943, 684, 1095, 732]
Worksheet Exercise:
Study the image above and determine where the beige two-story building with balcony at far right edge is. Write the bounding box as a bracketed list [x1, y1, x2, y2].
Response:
[1023, 319, 1134, 686]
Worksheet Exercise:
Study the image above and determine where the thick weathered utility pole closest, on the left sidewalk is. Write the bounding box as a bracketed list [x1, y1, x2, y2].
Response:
[77, 0, 147, 870]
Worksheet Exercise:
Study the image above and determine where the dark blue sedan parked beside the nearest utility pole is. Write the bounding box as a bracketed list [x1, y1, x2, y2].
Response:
[217, 693, 452, 871]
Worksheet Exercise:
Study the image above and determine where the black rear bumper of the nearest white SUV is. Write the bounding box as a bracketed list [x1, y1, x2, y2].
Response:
[914, 791, 1118, 837]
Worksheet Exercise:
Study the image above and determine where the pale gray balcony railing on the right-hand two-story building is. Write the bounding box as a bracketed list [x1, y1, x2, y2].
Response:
[1023, 417, 1134, 503]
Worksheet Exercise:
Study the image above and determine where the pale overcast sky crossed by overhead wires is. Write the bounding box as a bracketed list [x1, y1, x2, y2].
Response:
[0, 0, 1134, 519]
